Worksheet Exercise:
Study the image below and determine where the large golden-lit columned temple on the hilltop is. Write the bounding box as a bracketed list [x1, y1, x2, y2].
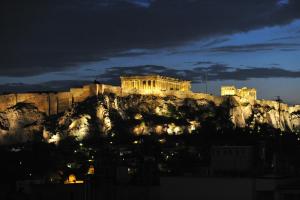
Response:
[121, 75, 191, 95]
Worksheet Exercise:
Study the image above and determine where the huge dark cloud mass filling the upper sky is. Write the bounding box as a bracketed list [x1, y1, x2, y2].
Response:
[0, 0, 300, 76]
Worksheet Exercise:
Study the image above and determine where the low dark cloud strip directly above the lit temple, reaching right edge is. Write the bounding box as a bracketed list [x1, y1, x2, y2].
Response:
[97, 63, 300, 85]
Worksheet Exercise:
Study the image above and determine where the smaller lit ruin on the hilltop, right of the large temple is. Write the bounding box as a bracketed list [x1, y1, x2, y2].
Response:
[221, 85, 257, 100]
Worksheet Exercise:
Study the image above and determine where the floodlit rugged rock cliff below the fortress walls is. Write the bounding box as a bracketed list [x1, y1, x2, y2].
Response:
[0, 94, 300, 145]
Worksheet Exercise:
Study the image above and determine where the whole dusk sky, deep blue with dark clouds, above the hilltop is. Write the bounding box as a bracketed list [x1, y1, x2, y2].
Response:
[0, 0, 300, 104]
